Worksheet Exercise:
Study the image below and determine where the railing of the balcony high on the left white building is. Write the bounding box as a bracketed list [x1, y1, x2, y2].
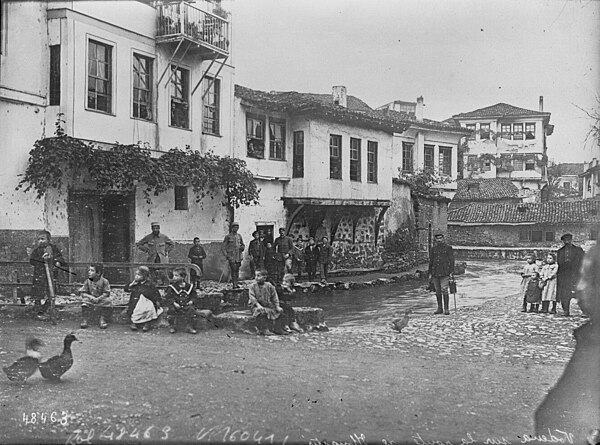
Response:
[156, 2, 230, 54]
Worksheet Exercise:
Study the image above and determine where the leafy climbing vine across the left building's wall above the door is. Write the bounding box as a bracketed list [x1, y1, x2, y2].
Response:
[17, 120, 260, 208]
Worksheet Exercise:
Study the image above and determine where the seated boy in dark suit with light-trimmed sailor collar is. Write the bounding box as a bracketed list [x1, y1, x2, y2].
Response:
[165, 268, 197, 334]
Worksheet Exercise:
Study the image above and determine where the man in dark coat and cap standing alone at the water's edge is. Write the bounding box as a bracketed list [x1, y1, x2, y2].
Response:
[429, 233, 454, 315]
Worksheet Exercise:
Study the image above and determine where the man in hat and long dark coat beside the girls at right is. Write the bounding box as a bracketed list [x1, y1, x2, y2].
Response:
[555, 233, 584, 317]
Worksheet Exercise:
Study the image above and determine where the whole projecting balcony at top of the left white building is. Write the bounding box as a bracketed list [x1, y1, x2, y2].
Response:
[156, 1, 231, 58]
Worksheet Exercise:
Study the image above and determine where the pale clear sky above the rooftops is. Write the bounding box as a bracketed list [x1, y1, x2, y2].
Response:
[230, 0, 600, 162]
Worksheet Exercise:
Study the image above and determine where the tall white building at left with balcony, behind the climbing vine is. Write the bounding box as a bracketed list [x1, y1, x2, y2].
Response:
[0, 0, 234, 278]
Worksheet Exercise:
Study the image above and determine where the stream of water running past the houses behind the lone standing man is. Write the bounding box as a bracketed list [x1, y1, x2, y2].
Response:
[294, 260, 524, 327]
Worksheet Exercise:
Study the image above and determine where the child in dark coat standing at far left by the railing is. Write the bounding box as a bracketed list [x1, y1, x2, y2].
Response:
[29, 230, 65, 315]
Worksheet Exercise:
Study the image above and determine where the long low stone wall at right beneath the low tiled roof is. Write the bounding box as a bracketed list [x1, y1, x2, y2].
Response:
[448, 224, 600, 248]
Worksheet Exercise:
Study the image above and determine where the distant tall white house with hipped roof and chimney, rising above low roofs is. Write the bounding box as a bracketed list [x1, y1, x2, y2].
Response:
[449, 96, 554, 201]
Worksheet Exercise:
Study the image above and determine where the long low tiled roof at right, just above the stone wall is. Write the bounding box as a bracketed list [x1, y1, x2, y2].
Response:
[448, 200, 600, 225]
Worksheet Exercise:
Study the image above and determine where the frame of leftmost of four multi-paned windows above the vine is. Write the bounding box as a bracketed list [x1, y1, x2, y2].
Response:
[85, 36, 115, 115]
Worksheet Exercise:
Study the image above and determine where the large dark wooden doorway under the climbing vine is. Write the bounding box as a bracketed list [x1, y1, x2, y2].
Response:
[67, 191, 135, 283]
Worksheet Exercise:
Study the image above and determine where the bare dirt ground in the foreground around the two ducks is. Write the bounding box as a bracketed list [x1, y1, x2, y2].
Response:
[0, 308, 565, 445]
